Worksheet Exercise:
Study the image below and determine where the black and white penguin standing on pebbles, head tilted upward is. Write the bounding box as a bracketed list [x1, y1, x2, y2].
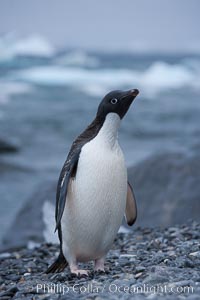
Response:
[46, 89, 139, 275]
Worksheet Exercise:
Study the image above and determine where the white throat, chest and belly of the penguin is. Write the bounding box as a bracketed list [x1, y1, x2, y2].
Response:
[62, 114, 127, 261]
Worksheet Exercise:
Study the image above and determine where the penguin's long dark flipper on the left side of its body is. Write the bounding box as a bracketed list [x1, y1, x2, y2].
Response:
[55, 148, 81, 231]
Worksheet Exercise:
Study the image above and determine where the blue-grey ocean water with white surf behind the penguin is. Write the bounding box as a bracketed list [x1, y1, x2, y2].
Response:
[0, 36, 200, 243]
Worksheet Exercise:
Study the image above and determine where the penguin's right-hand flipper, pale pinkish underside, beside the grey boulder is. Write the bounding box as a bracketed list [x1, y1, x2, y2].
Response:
[125, 182, 137, 226]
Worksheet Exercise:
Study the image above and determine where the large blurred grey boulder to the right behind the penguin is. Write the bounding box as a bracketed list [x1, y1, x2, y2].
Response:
[129, 153, 200, 226]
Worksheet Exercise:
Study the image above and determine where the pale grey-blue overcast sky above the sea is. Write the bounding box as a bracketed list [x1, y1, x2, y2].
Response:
[0, 0, 200, 52]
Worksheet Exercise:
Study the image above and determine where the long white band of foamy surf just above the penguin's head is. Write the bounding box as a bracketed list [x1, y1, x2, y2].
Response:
[13, 62, 200, 96]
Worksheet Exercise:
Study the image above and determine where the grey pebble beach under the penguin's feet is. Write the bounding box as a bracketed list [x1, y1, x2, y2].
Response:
[0, 222, 200, 300]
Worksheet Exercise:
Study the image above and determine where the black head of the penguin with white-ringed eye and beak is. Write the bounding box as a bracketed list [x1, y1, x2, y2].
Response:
[97, 89, 139, 119]
